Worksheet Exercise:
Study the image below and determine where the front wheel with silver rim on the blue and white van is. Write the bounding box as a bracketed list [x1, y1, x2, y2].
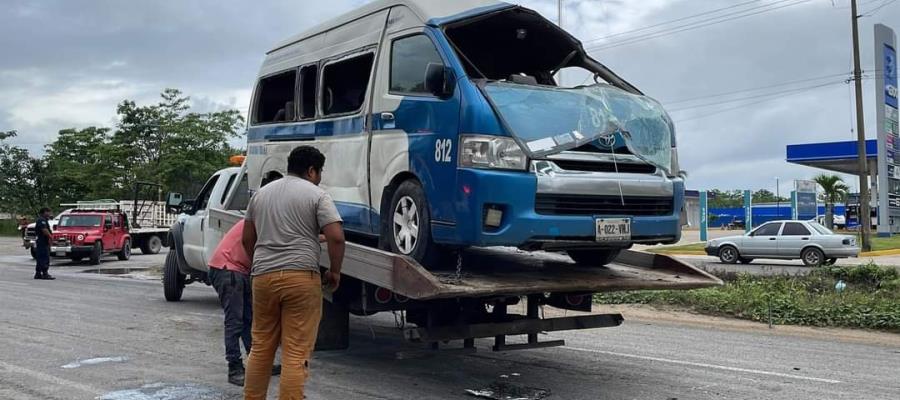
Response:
[383, 179, 440, 267]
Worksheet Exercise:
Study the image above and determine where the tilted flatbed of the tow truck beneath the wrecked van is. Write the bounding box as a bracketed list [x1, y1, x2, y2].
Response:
[209, 209, 722, 351]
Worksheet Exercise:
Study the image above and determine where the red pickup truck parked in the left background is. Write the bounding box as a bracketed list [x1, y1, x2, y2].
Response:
[50, 210, 131, 265]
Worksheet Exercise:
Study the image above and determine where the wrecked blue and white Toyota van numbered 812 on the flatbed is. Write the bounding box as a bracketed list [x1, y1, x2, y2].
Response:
[246, 0, 684, 265]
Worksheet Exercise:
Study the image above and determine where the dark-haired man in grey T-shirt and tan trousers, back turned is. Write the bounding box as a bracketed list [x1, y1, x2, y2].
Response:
[242, 146, 344, 400]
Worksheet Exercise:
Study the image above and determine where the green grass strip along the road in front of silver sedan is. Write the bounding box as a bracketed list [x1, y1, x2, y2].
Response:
[594, 264, 900, 332]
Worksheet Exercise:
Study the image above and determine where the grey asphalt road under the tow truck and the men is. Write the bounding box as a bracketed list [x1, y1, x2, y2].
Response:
[0, 239, 900, 400]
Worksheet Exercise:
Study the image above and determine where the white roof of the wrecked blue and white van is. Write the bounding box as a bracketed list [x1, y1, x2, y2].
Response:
[269, 0, 515, 53]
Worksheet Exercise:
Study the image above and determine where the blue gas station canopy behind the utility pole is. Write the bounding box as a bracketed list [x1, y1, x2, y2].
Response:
[787, 139, 878, 175]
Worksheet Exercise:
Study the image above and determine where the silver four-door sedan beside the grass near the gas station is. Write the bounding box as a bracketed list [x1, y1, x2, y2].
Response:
[706, 221, 859, 266]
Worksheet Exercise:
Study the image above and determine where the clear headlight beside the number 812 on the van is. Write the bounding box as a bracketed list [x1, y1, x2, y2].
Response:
[459, 135, 528, 171]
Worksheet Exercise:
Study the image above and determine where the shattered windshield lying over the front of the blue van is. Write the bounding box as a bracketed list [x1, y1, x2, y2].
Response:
[484, 82, 677, 173]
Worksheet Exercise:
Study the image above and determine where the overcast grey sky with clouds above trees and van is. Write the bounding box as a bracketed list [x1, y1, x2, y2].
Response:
[0, 0, 900, 194]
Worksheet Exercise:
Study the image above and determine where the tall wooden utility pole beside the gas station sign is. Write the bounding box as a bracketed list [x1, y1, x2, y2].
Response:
[850, 0, 872, 251]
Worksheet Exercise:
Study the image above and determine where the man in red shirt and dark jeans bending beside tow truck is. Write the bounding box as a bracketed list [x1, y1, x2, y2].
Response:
[208, 220, 281, 386]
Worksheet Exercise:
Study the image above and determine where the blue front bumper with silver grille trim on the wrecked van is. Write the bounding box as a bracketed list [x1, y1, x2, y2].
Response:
[432, 169, 684, 250]
